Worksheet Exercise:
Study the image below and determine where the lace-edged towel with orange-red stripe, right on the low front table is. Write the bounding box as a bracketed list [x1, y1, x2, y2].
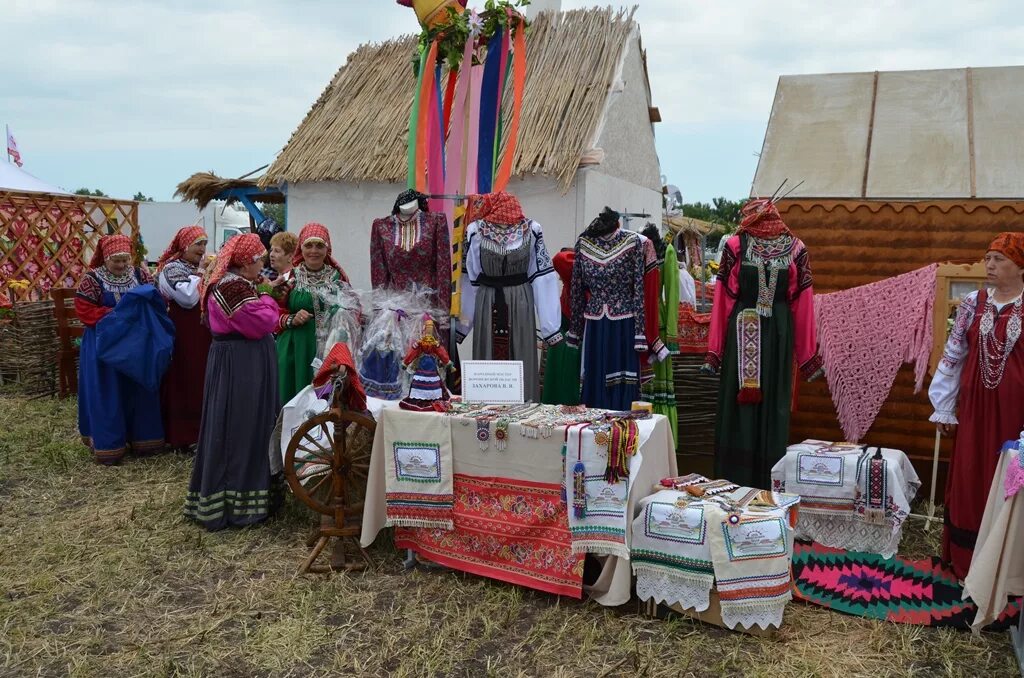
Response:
[705, 501, 793, 629]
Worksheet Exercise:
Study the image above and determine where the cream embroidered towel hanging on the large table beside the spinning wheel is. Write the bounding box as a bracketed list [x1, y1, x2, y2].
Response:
[383, 412, 455, 529]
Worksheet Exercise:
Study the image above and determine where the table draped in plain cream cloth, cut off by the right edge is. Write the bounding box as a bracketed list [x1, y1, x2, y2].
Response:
[964, 448, 1024, 643]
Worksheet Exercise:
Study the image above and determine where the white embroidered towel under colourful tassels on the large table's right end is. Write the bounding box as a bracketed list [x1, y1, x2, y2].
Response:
[564, 418, 656, 560]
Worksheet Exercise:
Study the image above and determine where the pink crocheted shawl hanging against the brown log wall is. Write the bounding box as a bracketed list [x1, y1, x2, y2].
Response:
[814, 264, 938, 442]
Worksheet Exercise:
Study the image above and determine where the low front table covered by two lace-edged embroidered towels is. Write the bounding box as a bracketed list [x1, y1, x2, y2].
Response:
[632, 476, 800, 632]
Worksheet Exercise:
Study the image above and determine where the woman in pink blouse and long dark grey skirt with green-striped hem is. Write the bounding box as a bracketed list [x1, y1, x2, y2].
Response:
[184, 234, 281, 531]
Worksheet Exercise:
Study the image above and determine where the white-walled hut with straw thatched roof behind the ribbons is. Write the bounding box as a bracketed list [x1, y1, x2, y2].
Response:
[261, 9, 662, 287]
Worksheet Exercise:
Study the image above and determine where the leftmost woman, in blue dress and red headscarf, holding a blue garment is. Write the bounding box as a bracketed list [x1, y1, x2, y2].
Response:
[75, 236, 164, 465]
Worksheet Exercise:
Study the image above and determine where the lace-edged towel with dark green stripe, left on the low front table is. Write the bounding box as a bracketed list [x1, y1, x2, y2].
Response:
[630, 490, 715, 611]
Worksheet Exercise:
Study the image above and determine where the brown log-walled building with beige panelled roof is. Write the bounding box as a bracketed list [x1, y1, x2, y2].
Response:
[752, 67, 1024, 496]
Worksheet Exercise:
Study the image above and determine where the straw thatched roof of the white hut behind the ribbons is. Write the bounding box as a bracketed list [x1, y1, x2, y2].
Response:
[261, 8, 636, 189]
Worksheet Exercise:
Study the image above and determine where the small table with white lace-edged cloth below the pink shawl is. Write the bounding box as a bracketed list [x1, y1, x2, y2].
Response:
[771, 440, 921, 558]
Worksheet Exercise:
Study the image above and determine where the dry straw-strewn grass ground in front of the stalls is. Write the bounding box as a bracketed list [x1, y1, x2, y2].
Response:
[0, 396, 1016, 678]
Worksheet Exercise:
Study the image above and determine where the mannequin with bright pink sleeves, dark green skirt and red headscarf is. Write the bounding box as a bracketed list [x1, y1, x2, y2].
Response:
[705, 200, 821, 488]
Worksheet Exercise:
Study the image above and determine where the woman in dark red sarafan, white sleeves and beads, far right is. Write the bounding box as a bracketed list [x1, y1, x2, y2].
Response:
[928, 232, 1024, 579]
